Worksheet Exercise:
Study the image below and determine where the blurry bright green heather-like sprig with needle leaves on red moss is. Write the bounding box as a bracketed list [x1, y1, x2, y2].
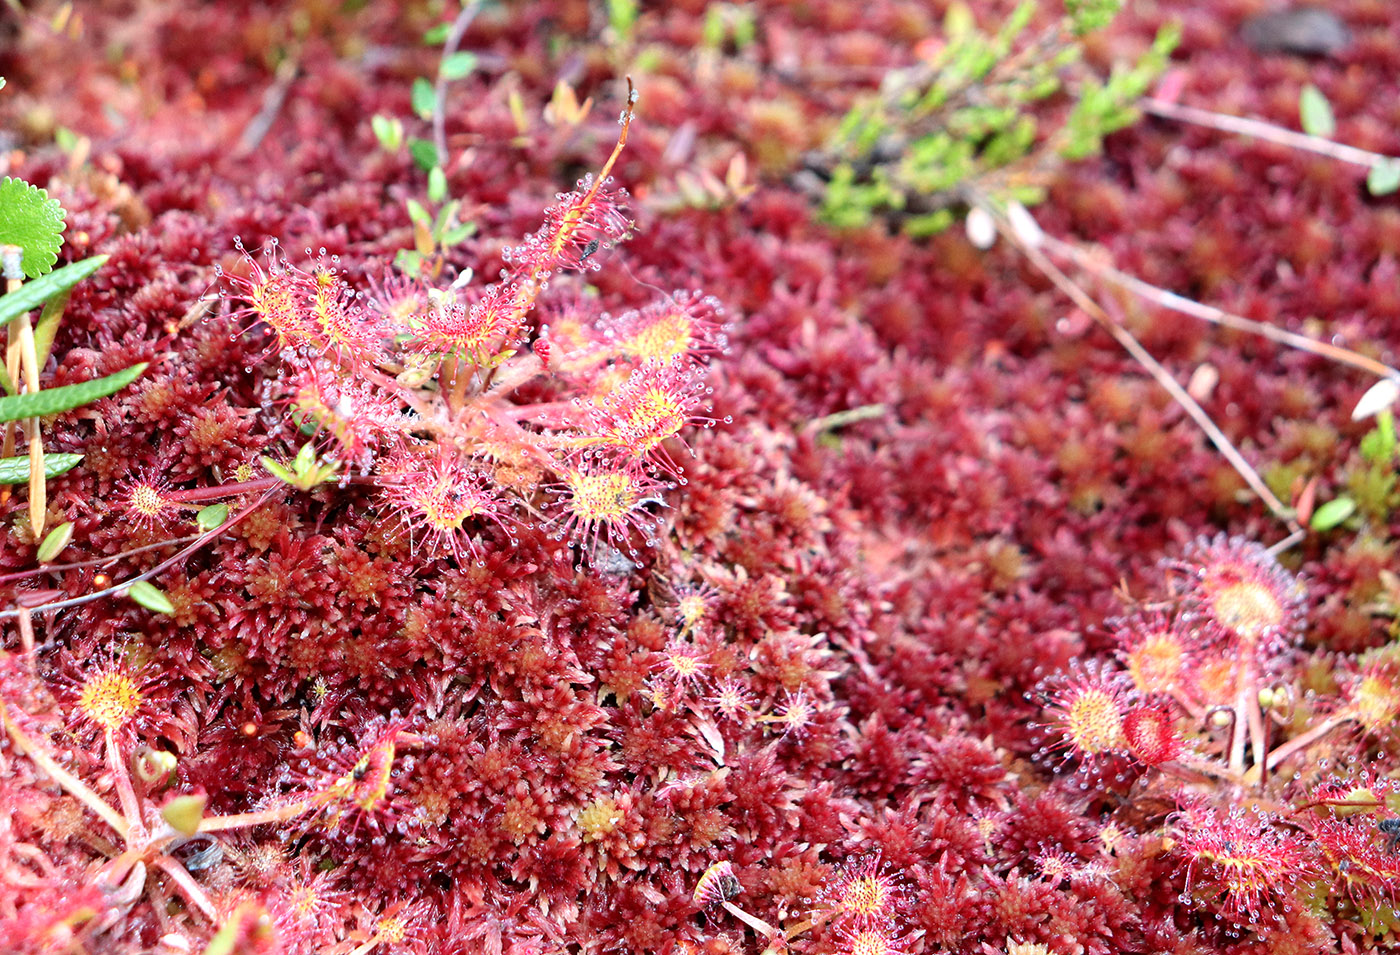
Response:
[822, 0, 1177, 235]
